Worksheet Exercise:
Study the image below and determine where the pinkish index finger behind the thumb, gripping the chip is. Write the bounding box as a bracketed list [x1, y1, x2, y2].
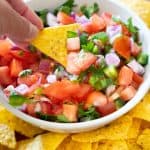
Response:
[7, 0, 43, 29]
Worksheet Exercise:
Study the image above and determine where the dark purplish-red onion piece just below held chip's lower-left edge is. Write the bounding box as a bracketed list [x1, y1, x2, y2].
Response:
[39, 59, 50, 74]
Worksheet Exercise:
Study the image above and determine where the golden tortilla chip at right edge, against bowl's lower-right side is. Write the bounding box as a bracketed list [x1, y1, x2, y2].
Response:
[129, 93, 150, 122]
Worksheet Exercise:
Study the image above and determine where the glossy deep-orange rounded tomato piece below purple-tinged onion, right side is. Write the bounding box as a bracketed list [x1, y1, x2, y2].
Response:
[113, 36, 131, 59]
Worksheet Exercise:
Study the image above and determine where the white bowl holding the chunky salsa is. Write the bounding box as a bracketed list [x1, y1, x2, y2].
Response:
[0, 0, 150, 133]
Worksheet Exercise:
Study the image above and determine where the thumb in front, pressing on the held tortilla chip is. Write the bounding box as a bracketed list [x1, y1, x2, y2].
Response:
[0, 0, 38, 42]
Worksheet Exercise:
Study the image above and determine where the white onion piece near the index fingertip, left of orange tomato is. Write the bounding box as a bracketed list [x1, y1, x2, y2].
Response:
[47, 12, 59, 27]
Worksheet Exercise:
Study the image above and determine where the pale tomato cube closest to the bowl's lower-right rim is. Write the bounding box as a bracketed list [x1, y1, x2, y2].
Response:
[120, 86, 136, 101]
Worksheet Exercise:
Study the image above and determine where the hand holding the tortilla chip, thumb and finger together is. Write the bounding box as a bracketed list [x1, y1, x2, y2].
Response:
[0, 0, 43, 45]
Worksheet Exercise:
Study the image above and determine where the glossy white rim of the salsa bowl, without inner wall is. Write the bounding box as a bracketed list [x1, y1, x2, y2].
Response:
[0, 0, 150, 133]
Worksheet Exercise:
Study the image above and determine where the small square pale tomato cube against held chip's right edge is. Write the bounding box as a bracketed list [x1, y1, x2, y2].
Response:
[67, 37, 80, 51]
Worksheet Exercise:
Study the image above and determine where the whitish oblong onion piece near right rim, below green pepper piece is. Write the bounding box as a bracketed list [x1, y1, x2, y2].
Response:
[127, 59, 145, 75]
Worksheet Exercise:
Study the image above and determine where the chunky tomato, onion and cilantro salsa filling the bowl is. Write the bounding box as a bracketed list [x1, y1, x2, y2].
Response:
[0, 0, 148, 123]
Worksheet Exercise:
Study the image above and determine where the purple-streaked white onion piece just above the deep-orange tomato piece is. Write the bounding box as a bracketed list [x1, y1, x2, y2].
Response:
[106, 25, 122, 43]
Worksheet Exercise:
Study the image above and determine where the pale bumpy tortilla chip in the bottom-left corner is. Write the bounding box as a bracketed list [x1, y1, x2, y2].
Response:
[0, 124, 16, 148]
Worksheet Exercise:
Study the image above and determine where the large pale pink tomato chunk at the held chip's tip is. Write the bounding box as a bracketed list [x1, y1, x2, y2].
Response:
[66, 52, 97, 75]
